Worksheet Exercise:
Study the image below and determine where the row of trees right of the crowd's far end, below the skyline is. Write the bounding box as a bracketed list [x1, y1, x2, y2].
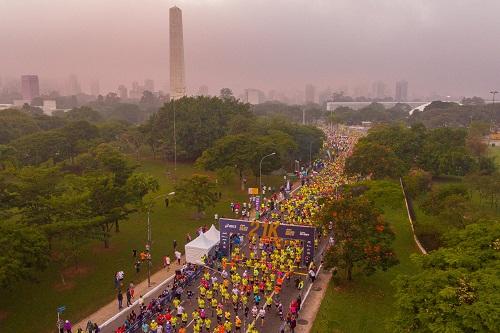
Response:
[346, 124, 495, 178]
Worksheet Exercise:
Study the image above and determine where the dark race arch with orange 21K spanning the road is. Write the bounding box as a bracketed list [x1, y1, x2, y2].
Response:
[219, 218, 316, 263]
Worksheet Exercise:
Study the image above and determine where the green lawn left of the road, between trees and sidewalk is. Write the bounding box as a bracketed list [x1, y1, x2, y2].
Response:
[0, 160, 281, 333]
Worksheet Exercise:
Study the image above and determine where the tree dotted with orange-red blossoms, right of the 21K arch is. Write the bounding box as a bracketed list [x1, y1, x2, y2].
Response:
[319, 196, 398, 281]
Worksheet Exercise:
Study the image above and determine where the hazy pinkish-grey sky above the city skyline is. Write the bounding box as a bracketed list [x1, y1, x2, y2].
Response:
[0, 0, 500, 96]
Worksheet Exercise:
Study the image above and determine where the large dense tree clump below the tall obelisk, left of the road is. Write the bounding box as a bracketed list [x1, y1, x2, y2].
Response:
[139, 96, 324, 175]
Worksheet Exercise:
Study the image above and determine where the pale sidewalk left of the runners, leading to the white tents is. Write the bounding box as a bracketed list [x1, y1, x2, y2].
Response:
[73, 256, 184, 331]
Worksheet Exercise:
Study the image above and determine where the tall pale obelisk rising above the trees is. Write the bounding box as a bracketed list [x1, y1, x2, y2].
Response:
[170, 6, 186, 99]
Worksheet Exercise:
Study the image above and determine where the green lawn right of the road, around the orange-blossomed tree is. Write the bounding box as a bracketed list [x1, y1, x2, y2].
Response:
[311, 182, 420, 333]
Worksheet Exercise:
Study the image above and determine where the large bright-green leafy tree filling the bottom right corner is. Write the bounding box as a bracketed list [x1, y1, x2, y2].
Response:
[393, 220, 500, 332]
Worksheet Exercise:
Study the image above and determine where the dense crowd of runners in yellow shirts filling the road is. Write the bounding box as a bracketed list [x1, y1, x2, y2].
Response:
[104, 126, 358, 333]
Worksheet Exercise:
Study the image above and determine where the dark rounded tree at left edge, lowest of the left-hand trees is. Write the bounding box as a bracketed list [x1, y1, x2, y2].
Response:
[0, 221, 49, 288]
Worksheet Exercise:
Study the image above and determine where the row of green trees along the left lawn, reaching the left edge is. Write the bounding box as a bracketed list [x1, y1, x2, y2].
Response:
[0, 144, 158, 286]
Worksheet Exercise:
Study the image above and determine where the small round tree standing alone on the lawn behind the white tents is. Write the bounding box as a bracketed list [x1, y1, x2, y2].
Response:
[174, 175, 219, 218]
